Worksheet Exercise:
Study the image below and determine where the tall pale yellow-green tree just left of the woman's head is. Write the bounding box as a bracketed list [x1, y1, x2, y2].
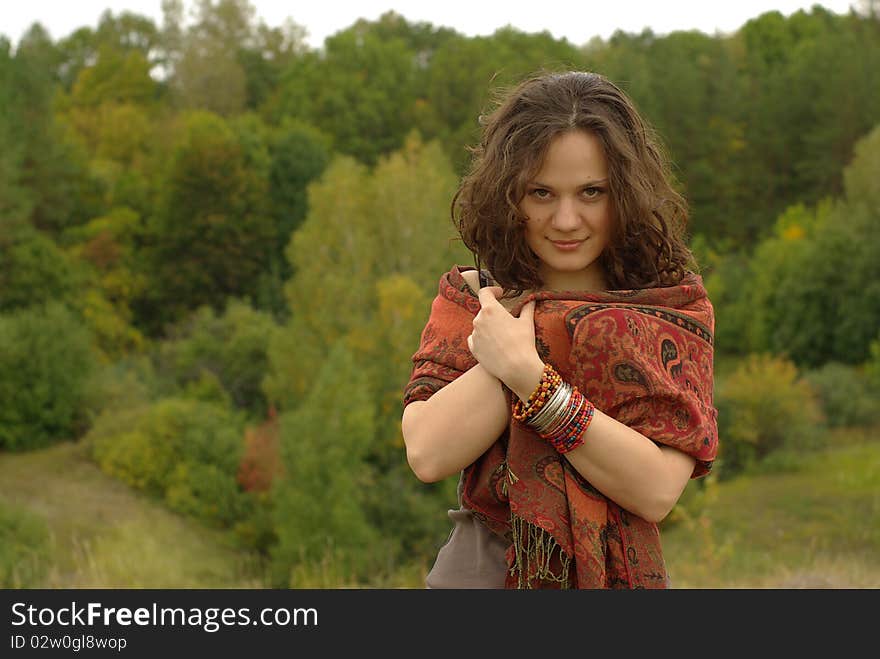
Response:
[266, 135, 471, 409]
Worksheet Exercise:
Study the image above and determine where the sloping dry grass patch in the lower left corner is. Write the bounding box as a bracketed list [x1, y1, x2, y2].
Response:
[0, 443, 261, 588]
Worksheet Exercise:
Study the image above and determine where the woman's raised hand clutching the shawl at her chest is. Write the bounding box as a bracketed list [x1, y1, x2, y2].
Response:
[468, 286, 544, 398]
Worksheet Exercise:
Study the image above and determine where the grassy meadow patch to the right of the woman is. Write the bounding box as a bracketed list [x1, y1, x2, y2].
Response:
[662, 430, 880, 588]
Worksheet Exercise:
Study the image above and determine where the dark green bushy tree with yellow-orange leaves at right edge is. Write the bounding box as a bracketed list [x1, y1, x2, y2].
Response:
[741, 124, 880, 367]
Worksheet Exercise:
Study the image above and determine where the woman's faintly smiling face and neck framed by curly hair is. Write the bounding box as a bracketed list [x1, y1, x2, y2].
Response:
[519, 129, 613, 291]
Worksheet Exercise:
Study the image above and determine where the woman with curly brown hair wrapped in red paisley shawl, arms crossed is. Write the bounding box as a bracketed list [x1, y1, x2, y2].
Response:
[402, 72, 717, 588]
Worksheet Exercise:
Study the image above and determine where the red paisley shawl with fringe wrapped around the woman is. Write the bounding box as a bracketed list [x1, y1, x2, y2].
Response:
[404, 266, 718, 588]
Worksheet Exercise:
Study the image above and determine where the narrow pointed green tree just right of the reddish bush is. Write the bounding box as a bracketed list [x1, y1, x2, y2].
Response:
[272, 342, 378, 587]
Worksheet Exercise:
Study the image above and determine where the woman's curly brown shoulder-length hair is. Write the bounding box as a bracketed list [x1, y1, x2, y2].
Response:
[451, 71, 695, 294]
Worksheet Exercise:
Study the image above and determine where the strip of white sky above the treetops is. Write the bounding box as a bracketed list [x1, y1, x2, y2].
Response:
[0, 0, 858, 48]
